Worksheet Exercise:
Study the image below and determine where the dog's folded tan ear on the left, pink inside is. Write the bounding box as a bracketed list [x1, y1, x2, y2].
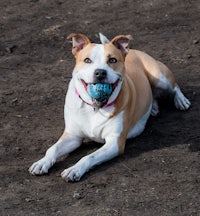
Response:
[67, 33, 90, 55]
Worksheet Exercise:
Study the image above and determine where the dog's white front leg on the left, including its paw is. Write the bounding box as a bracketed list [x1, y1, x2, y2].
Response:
[29, 133, 81, 175]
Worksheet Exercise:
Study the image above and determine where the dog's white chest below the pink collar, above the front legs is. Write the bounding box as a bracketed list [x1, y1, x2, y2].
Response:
[65, 81, 123, 143]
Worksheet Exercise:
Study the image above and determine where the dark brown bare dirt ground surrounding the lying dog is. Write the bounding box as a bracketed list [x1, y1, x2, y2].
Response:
[0, 0, 200, 216]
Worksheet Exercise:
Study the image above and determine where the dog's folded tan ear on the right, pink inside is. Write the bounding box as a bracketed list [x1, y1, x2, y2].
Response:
[111, 35, 133, 55]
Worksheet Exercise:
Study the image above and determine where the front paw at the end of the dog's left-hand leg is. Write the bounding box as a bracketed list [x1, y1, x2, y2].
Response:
[29, 157, 54, 175]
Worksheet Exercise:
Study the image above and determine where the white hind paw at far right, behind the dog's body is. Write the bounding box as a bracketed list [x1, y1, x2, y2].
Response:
[174, 87, 191, 110]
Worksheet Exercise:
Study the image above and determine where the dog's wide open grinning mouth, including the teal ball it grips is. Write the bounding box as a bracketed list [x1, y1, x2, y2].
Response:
[81, 79, 120, 109]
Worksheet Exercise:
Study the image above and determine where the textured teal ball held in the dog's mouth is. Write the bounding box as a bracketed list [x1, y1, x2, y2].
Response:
[87, 83, 112, 101]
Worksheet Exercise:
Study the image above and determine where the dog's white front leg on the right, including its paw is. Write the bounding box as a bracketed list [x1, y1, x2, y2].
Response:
[61, 137, 122, 181]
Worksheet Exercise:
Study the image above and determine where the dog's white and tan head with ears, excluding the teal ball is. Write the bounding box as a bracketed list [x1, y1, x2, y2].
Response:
[68, 34, 132, 108]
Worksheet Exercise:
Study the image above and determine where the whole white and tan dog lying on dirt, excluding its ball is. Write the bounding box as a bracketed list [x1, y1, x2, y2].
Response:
[29, 34, 190, 181]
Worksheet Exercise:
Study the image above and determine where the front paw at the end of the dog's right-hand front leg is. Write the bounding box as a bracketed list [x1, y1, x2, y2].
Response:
[61, 165, 83, 182]
